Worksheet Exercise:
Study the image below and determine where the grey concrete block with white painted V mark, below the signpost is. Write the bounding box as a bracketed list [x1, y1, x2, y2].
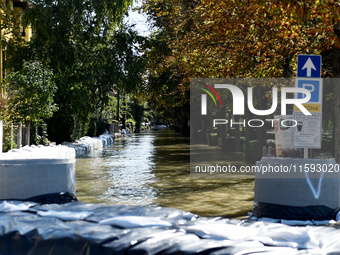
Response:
[254, 158, 340, 209]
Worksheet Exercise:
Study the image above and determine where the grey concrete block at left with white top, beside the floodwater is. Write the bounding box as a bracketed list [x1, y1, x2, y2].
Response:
[0, 146, 76, 200]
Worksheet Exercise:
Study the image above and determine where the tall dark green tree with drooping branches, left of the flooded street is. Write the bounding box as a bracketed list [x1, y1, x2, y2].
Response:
[17, 0, 132, 142]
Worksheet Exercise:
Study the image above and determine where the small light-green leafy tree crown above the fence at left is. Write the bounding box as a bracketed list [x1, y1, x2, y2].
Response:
[3, 62, 58, 124]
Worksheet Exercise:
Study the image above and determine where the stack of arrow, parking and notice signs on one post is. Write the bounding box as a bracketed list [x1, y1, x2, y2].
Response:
[293, 55, 323, 158]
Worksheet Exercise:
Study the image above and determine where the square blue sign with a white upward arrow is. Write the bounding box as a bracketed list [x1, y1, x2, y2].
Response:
[297, 55, 321, 78]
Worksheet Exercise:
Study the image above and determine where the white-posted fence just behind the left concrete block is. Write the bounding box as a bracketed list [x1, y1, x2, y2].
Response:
[0, 120, 30, 153]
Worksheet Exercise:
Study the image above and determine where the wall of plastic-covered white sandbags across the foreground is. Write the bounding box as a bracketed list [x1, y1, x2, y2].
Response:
[0, 201, 340, 255]
